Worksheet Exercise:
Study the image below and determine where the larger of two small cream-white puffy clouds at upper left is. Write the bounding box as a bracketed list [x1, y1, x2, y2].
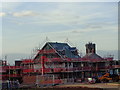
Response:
[12, 11, 37, 17]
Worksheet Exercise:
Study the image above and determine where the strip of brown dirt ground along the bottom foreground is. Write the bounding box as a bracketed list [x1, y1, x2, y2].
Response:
[18, 83, 120, 90]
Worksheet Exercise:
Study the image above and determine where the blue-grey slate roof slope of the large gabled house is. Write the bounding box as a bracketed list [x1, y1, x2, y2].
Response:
[48, 42, 80, 58]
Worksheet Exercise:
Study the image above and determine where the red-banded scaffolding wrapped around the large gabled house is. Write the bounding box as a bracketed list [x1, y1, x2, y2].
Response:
[22, 41, 116, 85]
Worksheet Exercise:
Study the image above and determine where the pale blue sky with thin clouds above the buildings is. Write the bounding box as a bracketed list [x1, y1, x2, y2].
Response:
[0, 2, 118, 63]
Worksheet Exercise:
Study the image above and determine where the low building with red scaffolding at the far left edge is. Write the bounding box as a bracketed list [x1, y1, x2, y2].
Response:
[0, 60, 22, 83]
